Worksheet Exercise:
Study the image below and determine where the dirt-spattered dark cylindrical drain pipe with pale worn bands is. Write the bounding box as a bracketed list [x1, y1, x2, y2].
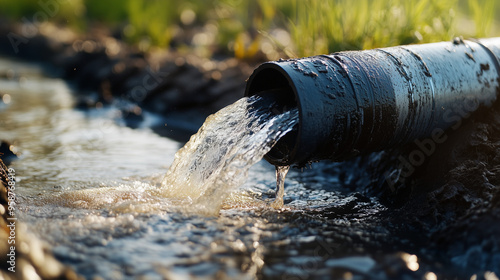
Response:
[245, 38, 500, 165]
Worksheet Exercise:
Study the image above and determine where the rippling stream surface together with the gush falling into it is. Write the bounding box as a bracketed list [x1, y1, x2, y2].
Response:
[0, 57, 462, 279]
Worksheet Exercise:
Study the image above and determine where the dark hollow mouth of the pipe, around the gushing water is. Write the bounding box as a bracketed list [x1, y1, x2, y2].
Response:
[245, 64, 300, 165]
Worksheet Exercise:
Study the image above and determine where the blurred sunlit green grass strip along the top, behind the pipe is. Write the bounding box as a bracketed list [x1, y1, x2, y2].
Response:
[0, 0, 500, 60]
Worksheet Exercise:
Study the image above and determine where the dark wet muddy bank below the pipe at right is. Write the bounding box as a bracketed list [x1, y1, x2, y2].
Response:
[349, 96, 500, 278]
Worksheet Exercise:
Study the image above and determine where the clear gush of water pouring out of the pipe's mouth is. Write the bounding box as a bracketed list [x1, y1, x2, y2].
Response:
[162, 97, 298, 214]
